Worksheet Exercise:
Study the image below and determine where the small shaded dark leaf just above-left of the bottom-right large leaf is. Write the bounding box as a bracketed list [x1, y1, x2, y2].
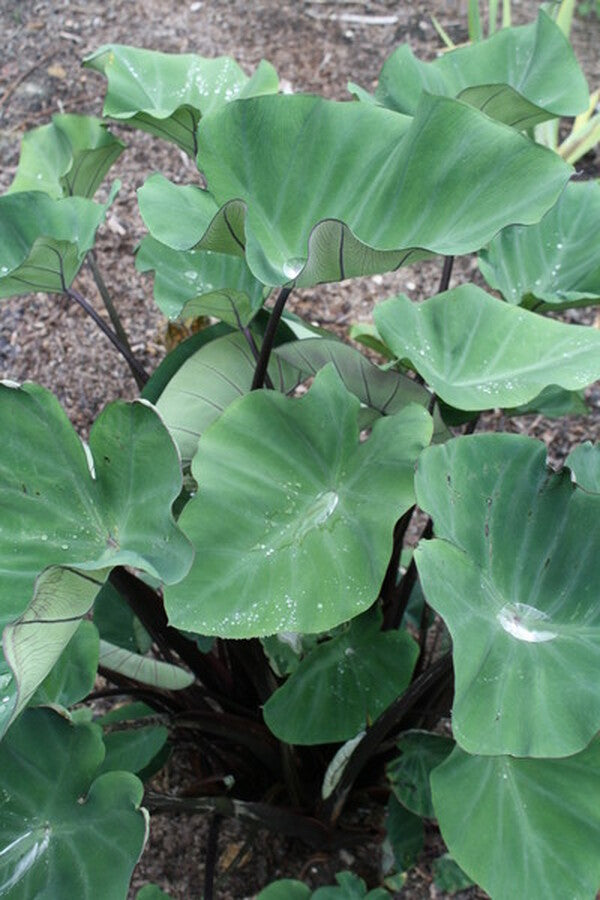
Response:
[386, 731, 454, 819]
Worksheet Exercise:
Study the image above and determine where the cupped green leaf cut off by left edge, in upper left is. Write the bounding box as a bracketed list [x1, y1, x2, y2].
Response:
[0, 185, 118, 297]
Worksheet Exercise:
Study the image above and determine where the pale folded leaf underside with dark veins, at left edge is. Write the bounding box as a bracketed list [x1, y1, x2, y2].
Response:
[0, 567, 108, 737]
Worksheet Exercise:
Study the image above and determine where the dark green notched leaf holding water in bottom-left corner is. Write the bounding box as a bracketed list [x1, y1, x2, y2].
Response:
[0, 709, 147, 900]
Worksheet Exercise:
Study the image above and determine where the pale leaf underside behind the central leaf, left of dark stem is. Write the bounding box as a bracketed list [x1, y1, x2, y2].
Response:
[156, 332, 300, 465]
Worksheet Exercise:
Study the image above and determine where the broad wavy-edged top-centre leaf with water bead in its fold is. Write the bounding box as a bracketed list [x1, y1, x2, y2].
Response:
[144, 95, 570, 287]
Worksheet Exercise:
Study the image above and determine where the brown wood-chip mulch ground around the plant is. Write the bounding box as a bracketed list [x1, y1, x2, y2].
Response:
[0, 0, 600, 900]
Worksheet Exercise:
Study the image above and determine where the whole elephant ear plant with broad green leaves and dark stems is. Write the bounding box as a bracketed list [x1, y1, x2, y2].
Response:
[0, 12, 600, 900]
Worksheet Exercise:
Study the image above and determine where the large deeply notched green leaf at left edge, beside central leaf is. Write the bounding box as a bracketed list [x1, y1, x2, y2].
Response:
[0, 384, 193, 626]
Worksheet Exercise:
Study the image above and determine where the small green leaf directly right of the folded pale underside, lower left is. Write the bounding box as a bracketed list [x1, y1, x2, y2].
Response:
[33, 620, 100, 707]
